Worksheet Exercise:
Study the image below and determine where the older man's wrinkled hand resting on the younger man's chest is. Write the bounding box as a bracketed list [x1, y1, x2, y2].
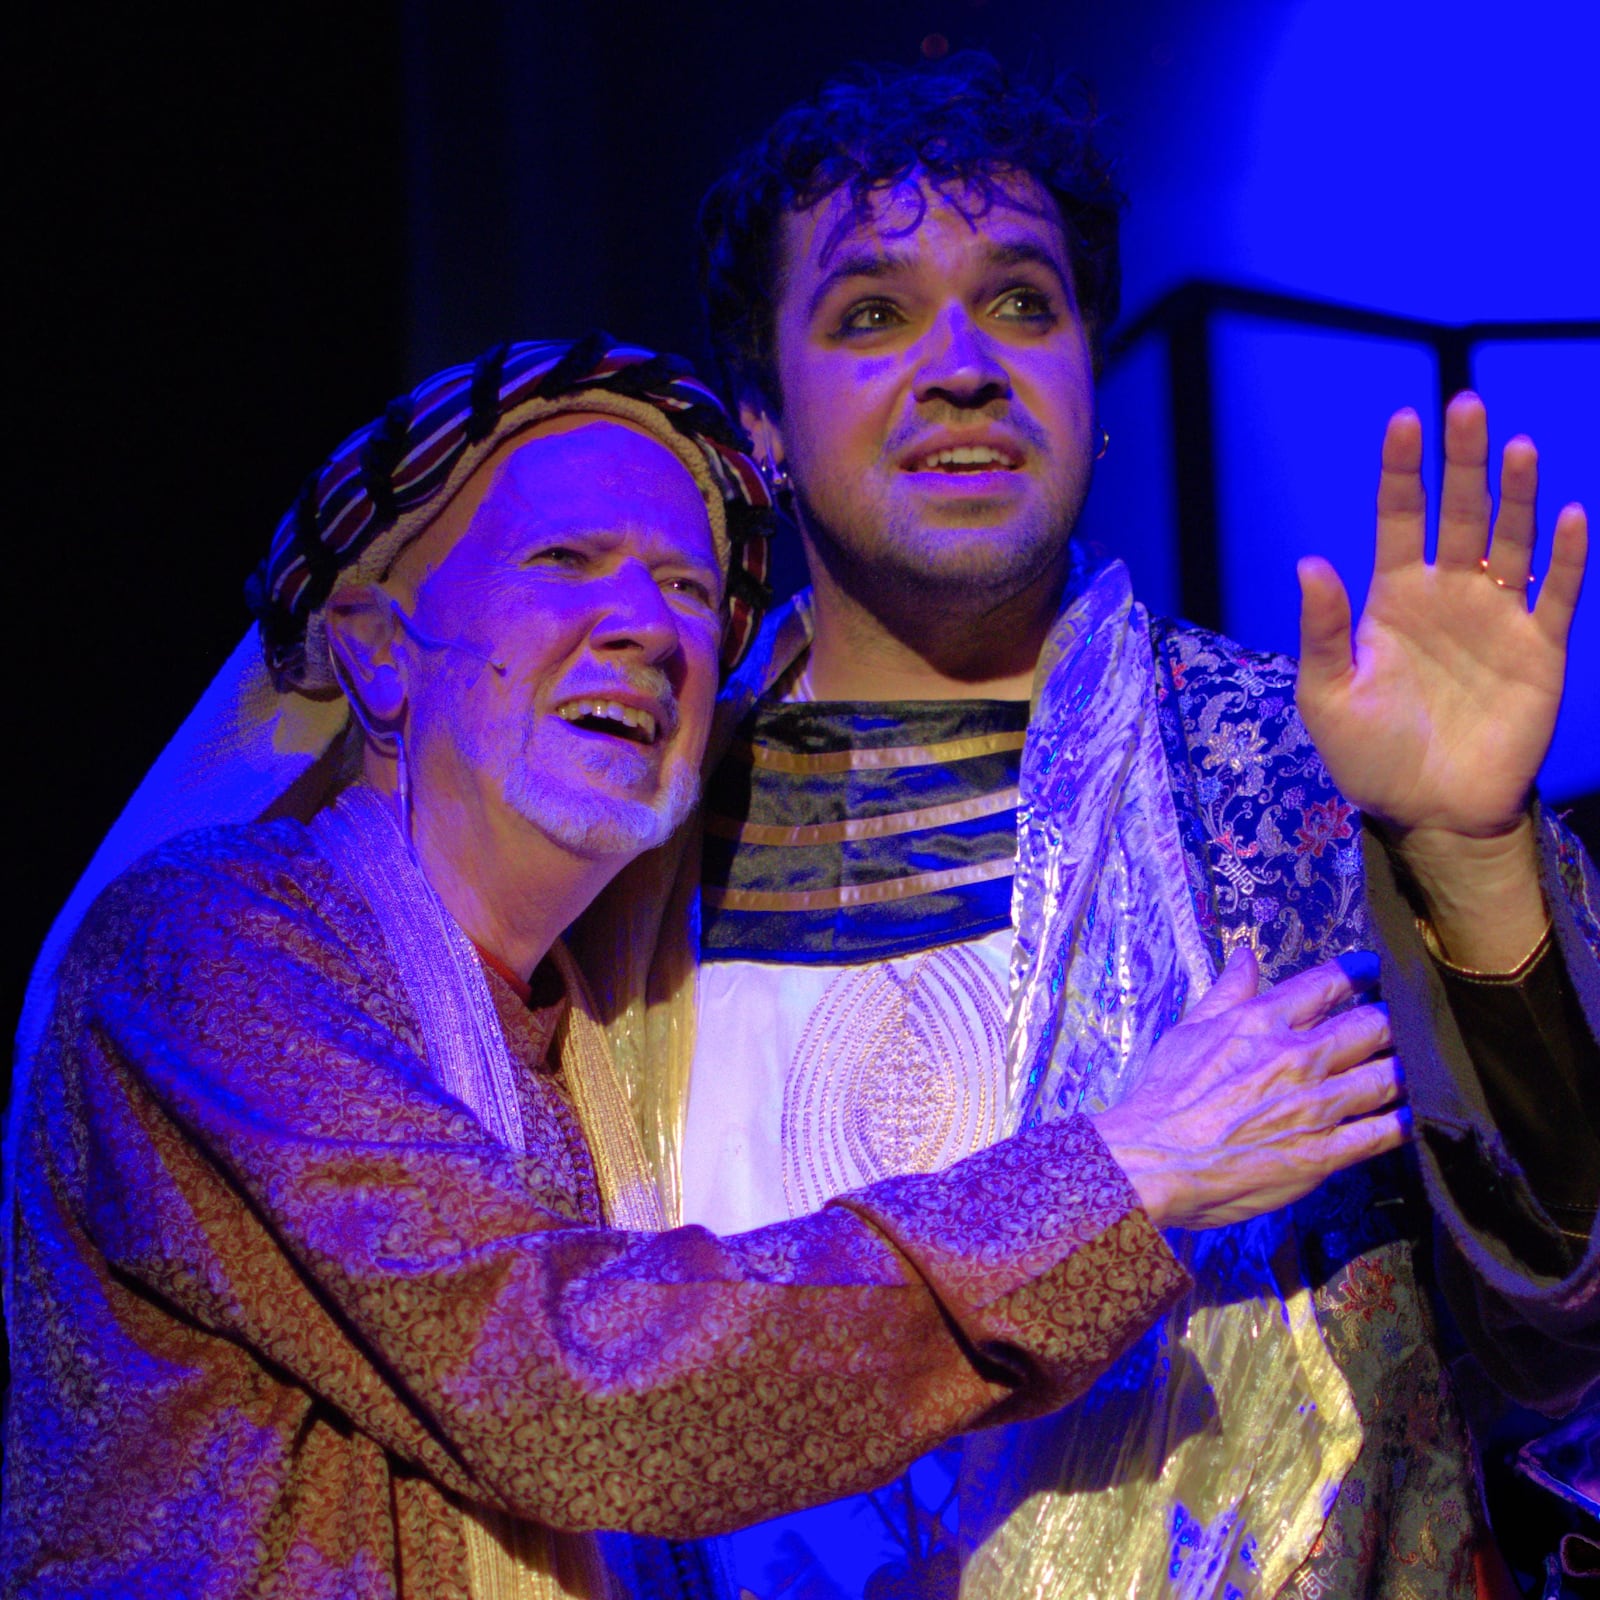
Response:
[1093, 949, 1408, 1229]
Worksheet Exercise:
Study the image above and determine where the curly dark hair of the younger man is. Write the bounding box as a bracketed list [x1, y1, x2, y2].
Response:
[699, 51, 1123, 405]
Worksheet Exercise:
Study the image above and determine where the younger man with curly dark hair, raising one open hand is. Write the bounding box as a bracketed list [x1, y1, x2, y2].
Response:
[569, 58, 1600, 1600]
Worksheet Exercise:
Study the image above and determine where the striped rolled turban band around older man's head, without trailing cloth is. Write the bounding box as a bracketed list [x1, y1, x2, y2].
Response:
[246, 333, 771, 694]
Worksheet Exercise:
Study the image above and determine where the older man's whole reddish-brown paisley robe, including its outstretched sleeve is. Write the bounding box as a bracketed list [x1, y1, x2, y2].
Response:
[0, 822, 1184, 1600]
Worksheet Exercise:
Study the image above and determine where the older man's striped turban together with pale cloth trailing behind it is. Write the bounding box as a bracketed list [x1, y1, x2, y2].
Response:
[12, 333, 771, 1094]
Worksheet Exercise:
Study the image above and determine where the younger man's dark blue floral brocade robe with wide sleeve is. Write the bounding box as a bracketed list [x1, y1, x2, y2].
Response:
[1152, 624, 1600, 1600]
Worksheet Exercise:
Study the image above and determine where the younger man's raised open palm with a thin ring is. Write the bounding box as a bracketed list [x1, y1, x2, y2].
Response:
[1298, 394, 1587, 850]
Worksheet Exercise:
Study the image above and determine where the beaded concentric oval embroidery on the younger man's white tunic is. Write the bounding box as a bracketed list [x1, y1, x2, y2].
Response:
[782, 946, 1005, 1216]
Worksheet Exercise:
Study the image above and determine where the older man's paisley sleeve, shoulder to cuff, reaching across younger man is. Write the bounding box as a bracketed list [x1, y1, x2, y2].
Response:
[51, 832, 1181, 1538]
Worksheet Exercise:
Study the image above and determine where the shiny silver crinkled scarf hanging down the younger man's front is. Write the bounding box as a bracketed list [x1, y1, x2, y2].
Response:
[960, 563, 1362, 1600]
